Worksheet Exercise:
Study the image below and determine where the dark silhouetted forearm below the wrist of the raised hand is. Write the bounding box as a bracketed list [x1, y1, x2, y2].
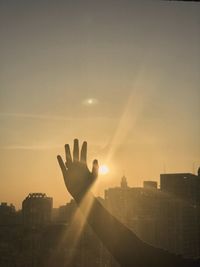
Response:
[76, 194, 196, 267]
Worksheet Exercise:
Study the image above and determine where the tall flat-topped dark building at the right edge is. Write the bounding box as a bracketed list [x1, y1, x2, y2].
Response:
[159, 169, 200, 258]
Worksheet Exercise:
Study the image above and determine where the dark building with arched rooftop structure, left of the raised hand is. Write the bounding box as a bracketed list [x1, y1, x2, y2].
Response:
[22, 193, 53, 227]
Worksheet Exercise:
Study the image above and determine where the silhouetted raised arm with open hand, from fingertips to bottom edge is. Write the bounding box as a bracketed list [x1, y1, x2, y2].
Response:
[57, 139, 200, 267]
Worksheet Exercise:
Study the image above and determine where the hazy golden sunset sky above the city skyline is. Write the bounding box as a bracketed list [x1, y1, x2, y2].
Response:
[0, 0, 200, 208]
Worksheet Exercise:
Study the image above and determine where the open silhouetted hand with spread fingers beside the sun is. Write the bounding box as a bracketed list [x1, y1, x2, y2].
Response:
[57, 139, 99, 202]
